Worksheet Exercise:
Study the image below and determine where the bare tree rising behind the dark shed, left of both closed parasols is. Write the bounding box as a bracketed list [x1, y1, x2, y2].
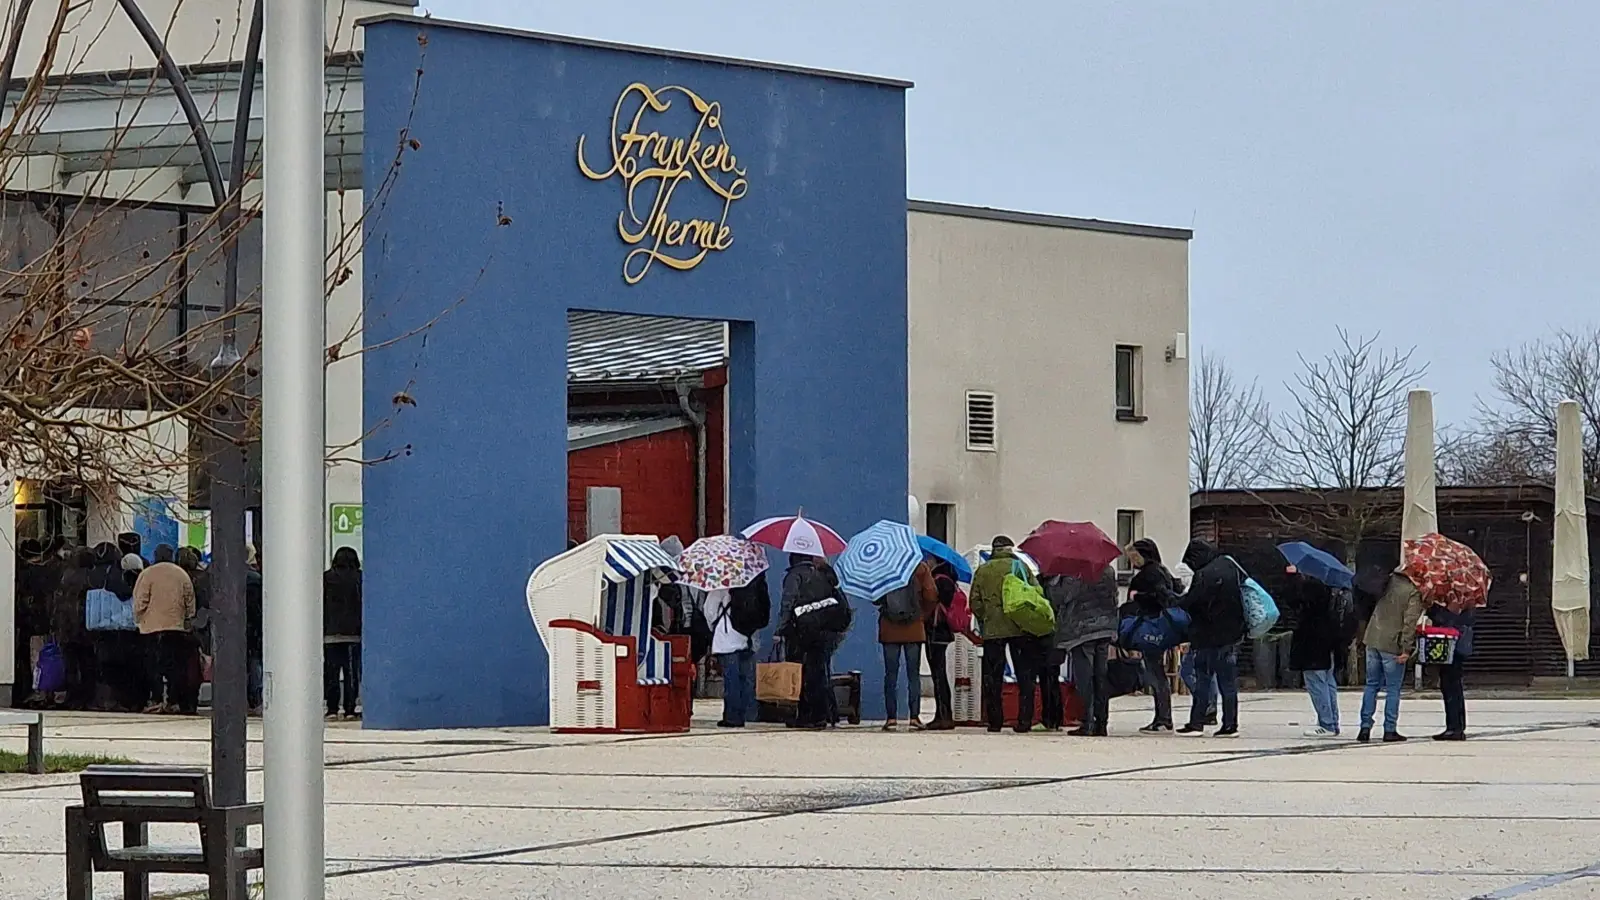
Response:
[1270, 328, 1427, 559]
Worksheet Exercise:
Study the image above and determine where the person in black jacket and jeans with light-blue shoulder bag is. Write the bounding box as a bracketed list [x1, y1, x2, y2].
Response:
[1178, 541, 1246, 738]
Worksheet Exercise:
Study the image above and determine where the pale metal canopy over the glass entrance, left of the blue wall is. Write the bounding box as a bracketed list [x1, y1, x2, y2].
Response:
[0, 53, 363, 205]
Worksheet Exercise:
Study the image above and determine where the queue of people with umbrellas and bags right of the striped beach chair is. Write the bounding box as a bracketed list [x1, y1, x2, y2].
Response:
[702, 535, 1474, 743]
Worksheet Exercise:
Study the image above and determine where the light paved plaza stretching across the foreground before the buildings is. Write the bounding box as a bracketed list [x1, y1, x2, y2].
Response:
[0, 693, 1600, 900]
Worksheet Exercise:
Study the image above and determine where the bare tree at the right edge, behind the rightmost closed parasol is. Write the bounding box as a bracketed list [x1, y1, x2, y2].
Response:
[1478, 325, 1600, 490]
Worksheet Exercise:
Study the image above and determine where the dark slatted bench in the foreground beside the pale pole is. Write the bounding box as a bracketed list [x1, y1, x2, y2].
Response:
[66, 765, 262, 900]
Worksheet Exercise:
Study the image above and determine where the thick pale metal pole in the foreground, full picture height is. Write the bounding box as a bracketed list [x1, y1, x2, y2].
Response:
[261, 0, 325, 900]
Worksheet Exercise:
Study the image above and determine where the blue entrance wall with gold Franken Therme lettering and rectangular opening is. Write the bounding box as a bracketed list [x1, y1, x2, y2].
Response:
[363, 18, 909, 729]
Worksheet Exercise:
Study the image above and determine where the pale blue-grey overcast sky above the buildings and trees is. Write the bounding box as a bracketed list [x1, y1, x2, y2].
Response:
[424, 0, 1600, 421]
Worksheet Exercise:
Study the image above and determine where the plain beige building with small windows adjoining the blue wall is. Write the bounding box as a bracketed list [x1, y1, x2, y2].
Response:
[907, 202, 1190, 560]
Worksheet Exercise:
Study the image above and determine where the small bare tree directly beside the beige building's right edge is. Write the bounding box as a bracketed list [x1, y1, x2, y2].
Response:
[1189, 352, 1272, 492]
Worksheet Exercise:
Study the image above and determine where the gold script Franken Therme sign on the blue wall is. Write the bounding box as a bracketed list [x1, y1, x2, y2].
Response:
[578, 82, 750, 285]
